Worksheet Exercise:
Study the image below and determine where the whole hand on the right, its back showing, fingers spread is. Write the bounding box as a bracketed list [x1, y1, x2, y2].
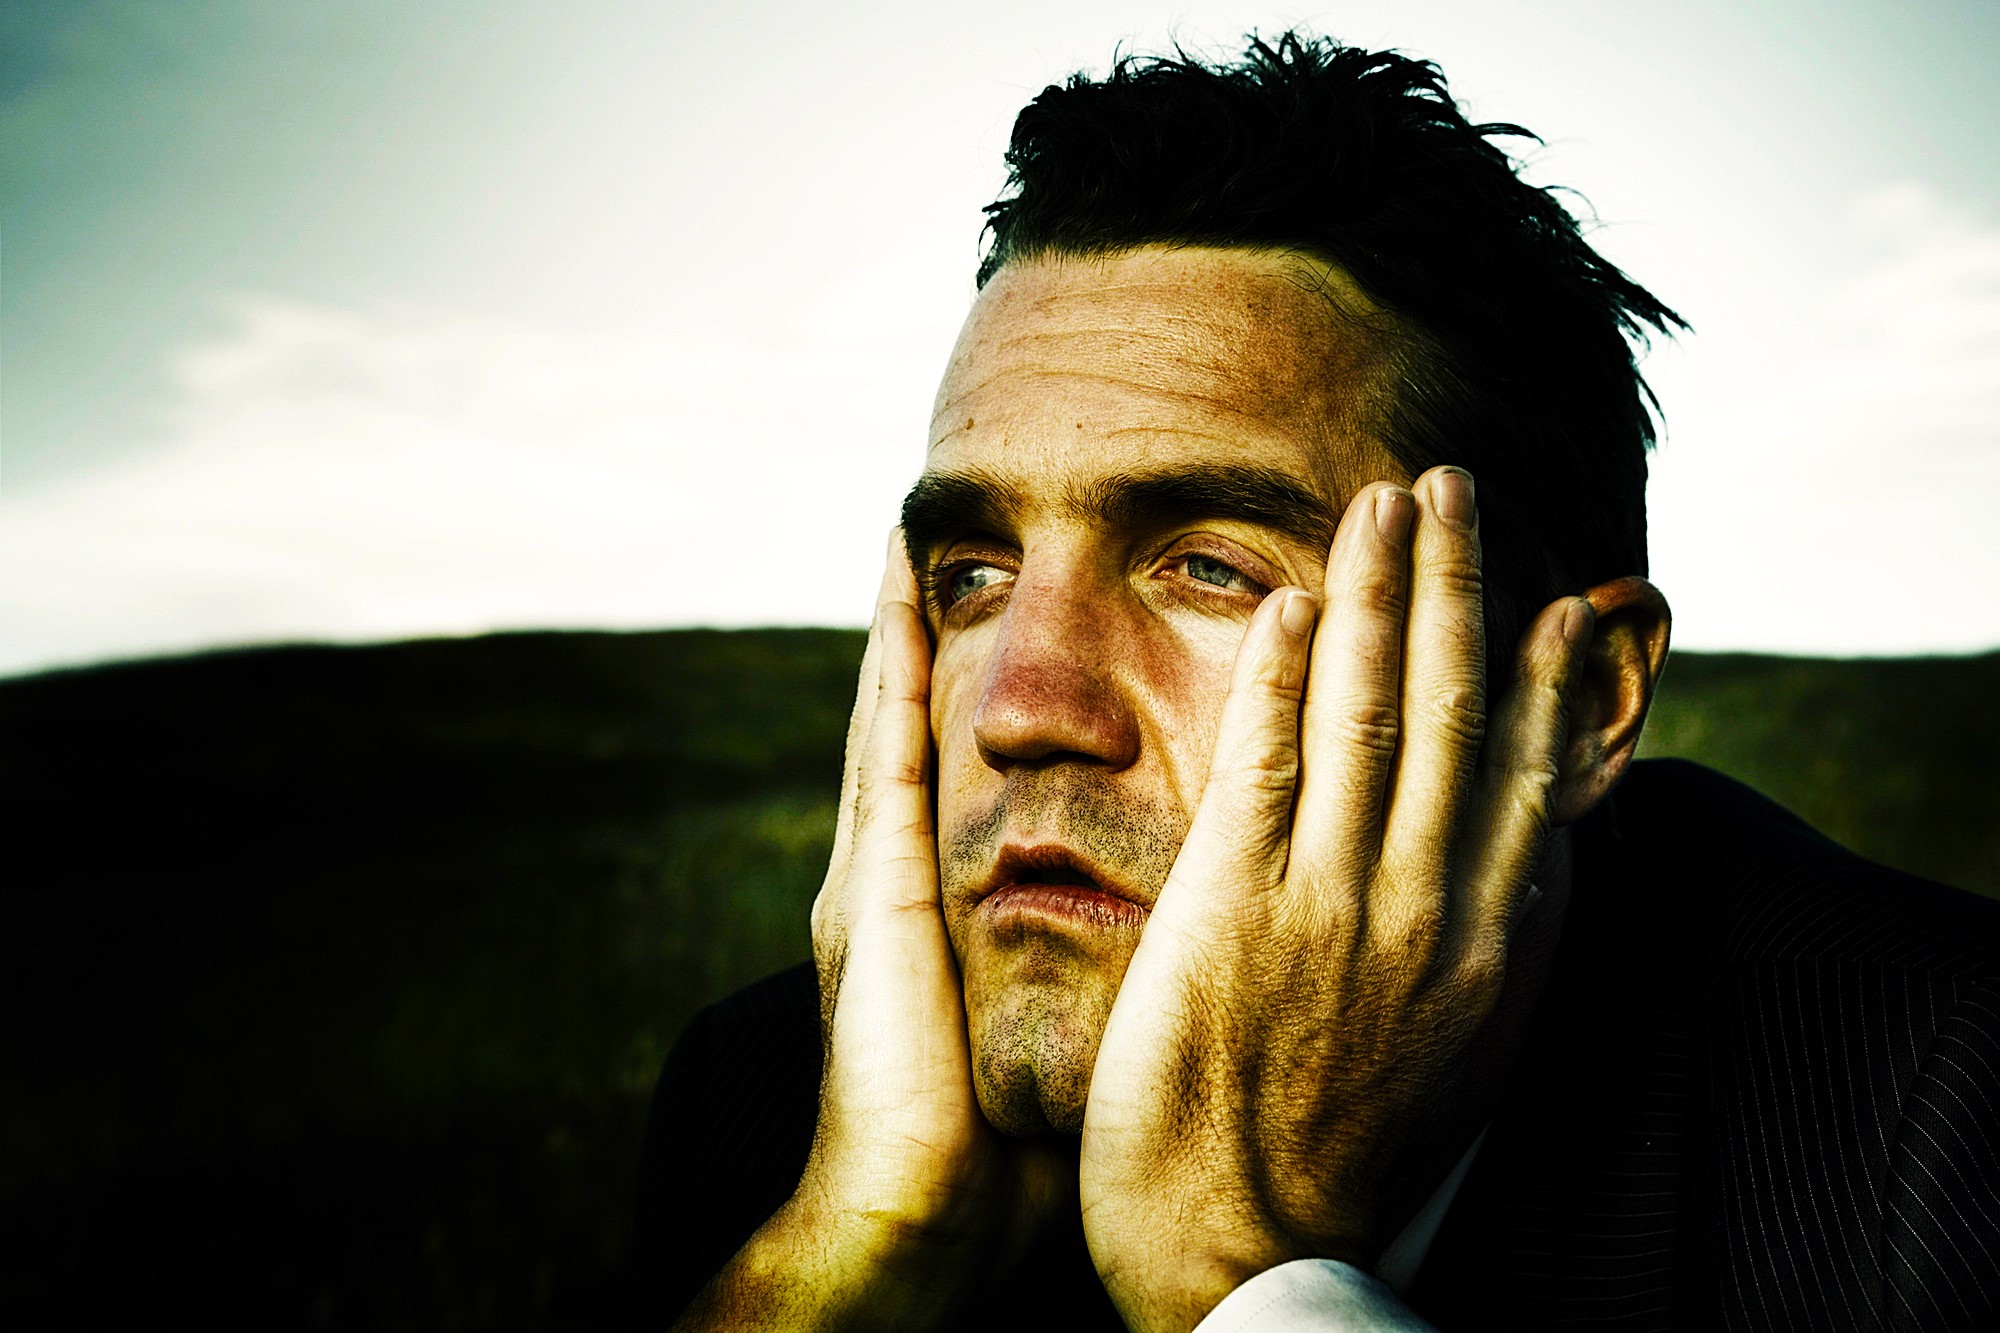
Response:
[1080, 468, 1592, 1333]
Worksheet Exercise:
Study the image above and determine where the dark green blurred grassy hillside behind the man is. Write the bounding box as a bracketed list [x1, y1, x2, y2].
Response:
[0, 630, 2000, 1329]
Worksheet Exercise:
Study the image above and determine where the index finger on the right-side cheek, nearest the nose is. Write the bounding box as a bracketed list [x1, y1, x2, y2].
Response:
[1154, 588, 1318, 915]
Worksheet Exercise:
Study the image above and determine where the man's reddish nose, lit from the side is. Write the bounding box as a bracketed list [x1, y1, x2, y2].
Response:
[972, 568, 1140, 771]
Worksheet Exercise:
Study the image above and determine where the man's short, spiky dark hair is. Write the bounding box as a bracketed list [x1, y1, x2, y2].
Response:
[978, 32, 1688, 664]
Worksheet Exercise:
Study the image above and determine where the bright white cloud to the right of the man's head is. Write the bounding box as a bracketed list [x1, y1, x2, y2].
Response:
[1650, 184, 2000, 652]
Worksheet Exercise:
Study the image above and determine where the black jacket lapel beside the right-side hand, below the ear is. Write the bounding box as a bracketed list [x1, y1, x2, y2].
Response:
[1410, 792, 1702, 1329]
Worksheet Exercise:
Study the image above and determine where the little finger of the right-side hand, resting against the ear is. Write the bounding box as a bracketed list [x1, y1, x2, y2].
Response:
[1466, 596, 1596, 941]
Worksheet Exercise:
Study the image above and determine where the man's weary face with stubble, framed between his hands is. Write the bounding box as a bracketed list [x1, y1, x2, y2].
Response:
[906, 248, 1410, 1133]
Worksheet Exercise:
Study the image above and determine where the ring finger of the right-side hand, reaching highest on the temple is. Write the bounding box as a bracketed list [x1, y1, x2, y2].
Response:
[1382, 468, 1486, 880]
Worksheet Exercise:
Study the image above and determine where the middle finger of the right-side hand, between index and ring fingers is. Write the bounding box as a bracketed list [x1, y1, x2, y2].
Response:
[1292, 484, 1416, 873]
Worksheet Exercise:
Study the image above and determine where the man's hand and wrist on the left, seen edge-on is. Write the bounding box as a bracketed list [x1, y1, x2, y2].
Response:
[676, 528, 1076, 1329]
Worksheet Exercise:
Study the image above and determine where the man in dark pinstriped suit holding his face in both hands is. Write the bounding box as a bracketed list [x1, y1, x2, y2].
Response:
[636, 36, 2000, 1333]
